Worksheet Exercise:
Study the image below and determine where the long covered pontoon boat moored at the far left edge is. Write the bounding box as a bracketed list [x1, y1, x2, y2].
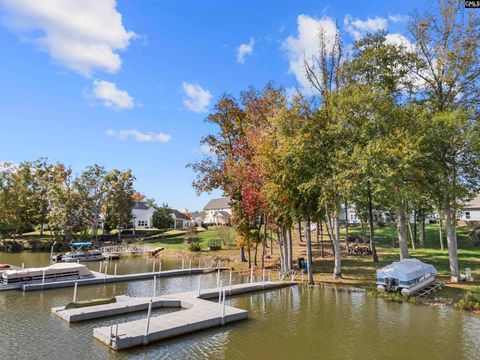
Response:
[0, 264, 94, 286]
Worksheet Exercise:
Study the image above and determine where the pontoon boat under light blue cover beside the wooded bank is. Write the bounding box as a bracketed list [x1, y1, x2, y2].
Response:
[377, 259, 437, 295]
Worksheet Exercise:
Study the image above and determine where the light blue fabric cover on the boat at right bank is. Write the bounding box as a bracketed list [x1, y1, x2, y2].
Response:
[377, 259, 437, 281]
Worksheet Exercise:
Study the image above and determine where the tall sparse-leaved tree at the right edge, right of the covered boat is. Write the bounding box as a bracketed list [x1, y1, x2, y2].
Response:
[407, 0, 480, 282]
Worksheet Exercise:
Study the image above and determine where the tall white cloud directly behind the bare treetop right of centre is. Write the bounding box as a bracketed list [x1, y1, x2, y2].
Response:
[282, 15, 337, 95]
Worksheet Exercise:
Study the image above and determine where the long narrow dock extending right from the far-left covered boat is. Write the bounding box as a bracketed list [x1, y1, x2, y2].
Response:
[19, 267, 229, 291]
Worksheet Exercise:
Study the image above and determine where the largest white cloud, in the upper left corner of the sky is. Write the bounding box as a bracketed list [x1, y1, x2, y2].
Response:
[0, 0, 135, 76]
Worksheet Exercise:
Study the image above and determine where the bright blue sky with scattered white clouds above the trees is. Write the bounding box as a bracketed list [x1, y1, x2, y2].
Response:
[0, 0, 428, 211]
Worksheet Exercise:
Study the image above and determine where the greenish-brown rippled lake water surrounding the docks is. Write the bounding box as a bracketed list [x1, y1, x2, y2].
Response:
[0, 253, 480, 360]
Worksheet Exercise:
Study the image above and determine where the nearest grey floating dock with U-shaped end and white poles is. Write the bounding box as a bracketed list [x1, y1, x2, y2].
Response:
[52, 281, 295, 350]
